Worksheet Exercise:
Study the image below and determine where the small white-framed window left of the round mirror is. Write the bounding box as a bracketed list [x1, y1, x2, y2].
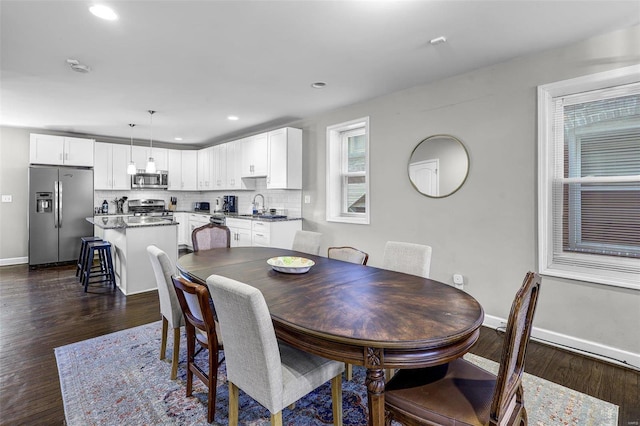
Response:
[327, 117, 369, 224]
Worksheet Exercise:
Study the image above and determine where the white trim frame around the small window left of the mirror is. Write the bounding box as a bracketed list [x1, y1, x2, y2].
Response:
[326, 117, 371, 225]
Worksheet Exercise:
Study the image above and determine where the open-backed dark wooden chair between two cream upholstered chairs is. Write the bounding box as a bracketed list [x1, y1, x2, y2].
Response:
[171, 276, 224, 423]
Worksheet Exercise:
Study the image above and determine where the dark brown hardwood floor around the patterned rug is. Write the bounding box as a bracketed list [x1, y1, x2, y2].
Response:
[0, 265, 640, 426]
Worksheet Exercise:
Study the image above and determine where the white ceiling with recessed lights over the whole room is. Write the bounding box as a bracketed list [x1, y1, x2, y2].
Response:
[0, 0, 640, 145]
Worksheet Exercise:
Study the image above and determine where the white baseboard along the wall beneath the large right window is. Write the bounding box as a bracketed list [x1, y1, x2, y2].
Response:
[483, 315, 640, 370]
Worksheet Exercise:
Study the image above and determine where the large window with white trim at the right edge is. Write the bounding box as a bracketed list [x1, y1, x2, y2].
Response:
[538, 66, 640, 289]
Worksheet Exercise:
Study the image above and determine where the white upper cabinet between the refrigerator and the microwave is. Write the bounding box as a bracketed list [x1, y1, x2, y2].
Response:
[93, 142, 131, 190]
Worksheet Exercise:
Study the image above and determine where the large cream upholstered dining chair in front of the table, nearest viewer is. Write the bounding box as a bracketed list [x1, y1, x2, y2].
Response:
[207, 275, 344, 426]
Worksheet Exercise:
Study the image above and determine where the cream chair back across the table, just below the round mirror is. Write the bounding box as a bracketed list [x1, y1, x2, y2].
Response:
[382, 241, 431, 278]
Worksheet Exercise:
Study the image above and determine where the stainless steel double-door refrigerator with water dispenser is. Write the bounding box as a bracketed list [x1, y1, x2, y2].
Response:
[29, 166, 93, 266]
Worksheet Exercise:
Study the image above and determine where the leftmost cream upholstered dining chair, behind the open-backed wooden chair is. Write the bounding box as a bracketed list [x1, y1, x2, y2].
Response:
[147, 245, 184, 380]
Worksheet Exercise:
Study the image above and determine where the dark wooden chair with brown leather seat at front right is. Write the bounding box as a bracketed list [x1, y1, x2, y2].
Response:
[384, 272, 541, 425]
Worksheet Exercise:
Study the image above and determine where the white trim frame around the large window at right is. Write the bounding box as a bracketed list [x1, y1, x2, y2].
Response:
[538, 65, 640, 289]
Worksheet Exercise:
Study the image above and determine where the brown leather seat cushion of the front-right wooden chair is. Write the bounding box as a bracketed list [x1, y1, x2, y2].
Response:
[384, 359, 496, 425]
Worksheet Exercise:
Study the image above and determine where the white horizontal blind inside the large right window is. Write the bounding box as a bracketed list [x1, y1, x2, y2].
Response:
[551, 83, 640, 273]
